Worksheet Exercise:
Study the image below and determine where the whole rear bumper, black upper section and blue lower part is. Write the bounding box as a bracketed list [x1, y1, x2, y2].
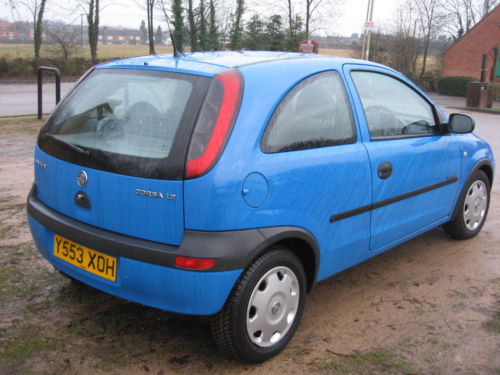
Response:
[27, 185, 319, 315]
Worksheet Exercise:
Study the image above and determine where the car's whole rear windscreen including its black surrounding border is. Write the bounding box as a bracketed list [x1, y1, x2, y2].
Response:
[39, 69, 210, 179]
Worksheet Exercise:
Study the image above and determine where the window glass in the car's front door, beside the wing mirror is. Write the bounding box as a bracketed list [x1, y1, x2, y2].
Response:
[351, 71, 440, 139]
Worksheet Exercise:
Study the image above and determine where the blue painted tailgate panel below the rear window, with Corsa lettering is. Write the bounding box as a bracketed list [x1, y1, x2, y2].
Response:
[35, 147, 184, 245]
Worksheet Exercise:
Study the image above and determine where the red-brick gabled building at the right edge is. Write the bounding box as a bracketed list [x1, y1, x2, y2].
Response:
[443, 5, 500, 80]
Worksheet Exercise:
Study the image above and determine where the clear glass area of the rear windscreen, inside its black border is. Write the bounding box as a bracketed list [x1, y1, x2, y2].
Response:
[47, 71, 193, 158]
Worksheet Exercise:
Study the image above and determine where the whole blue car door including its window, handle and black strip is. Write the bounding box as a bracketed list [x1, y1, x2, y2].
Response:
[346, 66, 460, 251]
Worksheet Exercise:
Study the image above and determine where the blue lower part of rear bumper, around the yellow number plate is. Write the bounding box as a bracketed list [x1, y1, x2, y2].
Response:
[28, 215, 241, 315]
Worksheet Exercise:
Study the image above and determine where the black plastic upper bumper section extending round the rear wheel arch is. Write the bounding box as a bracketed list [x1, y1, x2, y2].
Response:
[27, 185, 318, 272]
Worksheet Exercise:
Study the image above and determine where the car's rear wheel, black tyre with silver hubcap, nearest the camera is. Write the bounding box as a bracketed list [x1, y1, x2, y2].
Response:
[211, 248, 306, 363]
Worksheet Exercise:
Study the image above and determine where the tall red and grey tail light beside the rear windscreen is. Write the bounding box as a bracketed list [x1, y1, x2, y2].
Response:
[186, 70, 243, 178]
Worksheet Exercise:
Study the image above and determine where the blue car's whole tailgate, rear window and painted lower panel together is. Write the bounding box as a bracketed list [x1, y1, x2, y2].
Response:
[35, 69, 211, 245]
